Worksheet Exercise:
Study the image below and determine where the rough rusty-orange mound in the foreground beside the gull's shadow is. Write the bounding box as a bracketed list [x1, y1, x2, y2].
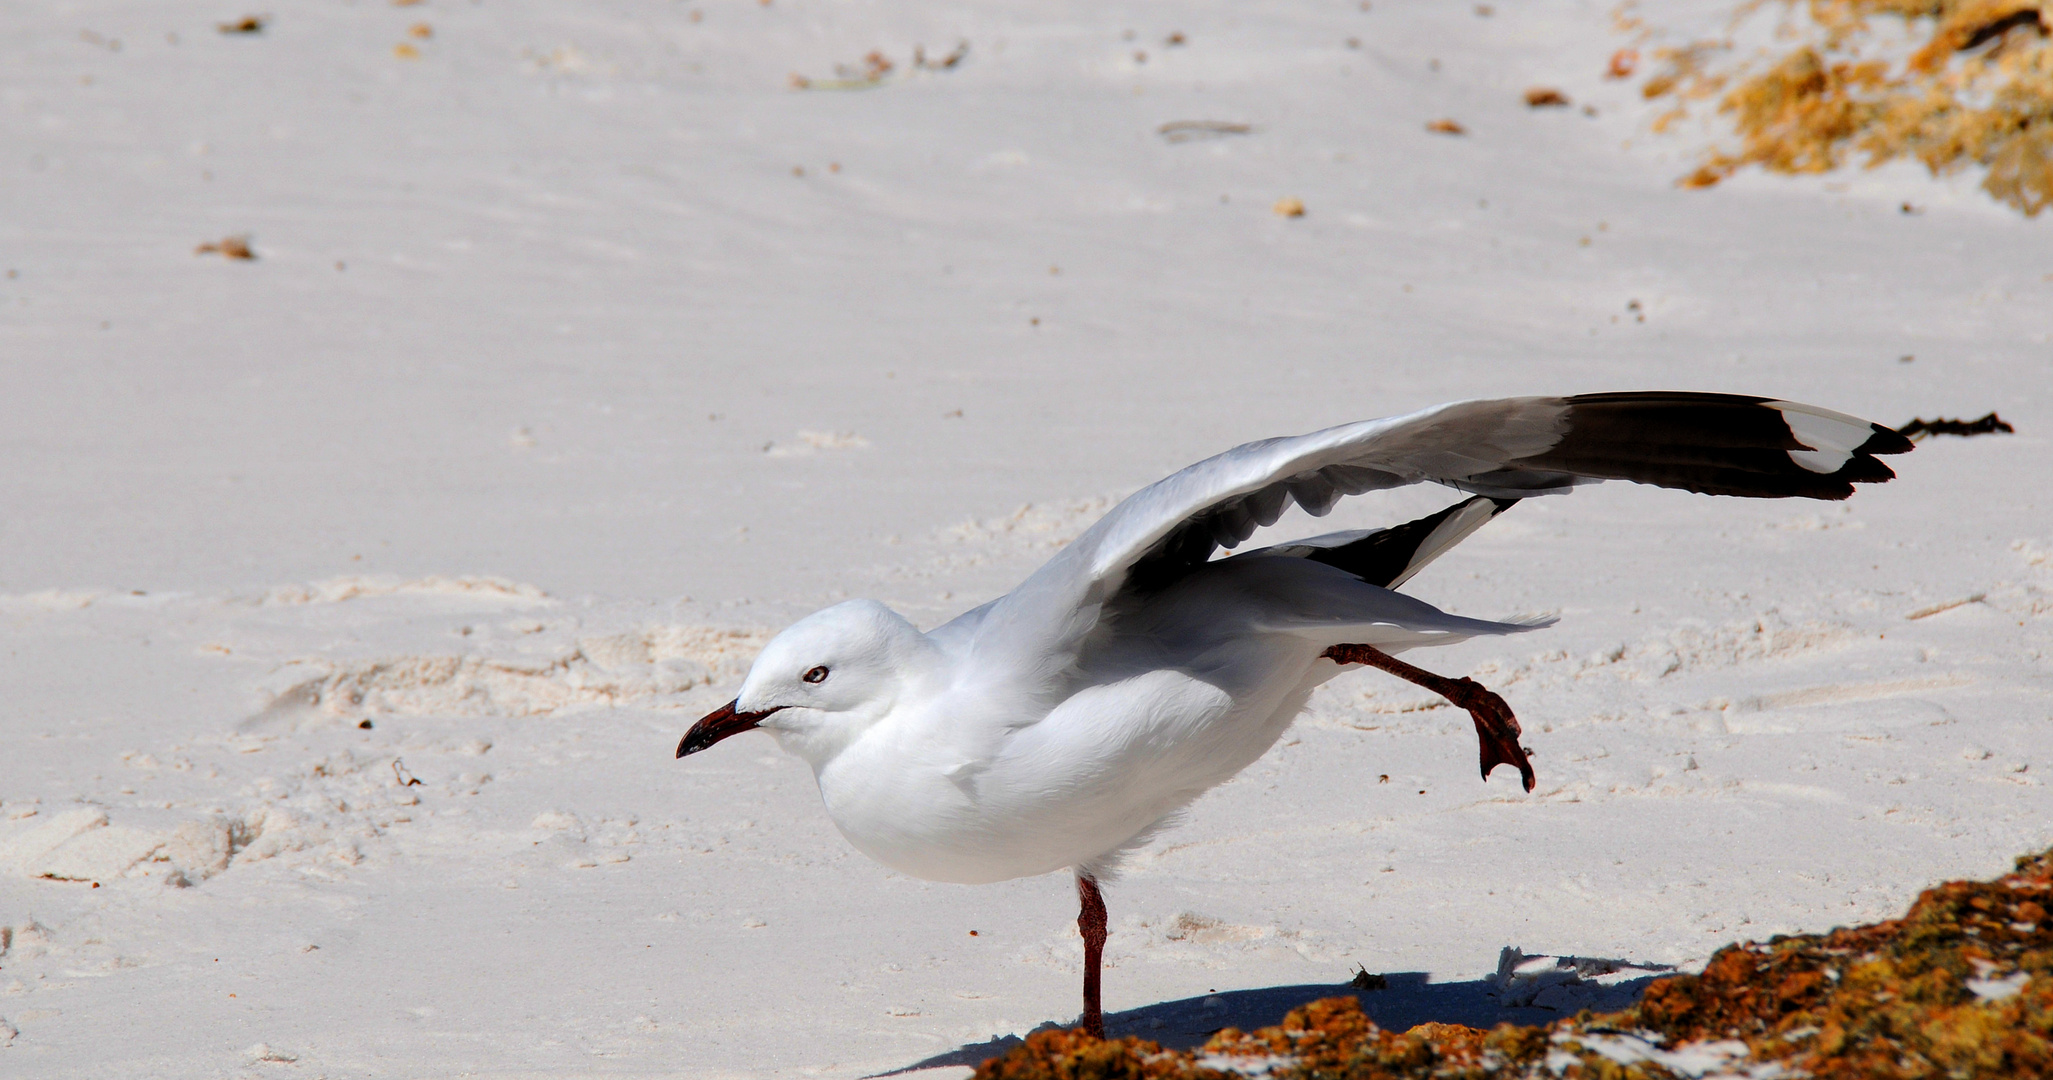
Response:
[975, 850, 2053, 1080]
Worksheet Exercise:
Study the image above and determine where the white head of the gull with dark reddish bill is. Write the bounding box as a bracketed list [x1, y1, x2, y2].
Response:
[677, 600, 934, 768]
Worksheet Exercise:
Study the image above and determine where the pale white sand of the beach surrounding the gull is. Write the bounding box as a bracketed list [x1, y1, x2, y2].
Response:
[0, 0, 2053, 1078]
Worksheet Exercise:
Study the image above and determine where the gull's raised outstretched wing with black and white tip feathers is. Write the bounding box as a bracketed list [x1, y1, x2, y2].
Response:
[971, 392, 1911, 682]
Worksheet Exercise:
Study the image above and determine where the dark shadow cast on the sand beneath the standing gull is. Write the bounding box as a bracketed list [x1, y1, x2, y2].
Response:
[866, 971, 1659, 1080]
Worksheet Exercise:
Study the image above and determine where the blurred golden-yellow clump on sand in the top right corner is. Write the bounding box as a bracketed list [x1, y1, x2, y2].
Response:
[1642, 0, 2053, 216]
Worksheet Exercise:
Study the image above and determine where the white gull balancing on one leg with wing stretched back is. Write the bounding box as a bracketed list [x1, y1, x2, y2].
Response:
[677, 392, 1911, 1037]
